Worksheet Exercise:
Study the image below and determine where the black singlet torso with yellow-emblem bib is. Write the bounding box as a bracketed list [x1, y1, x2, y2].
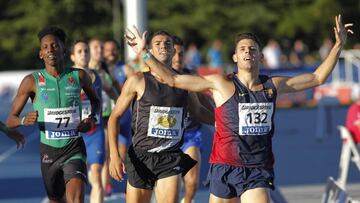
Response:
[132, 72, 187, 152]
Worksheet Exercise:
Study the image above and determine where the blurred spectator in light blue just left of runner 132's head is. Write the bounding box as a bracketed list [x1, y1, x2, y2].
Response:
[206, 39, 224, 69]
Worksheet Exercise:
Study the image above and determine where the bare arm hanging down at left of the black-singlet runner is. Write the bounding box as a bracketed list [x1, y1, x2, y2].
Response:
[108, 75, 143, 181]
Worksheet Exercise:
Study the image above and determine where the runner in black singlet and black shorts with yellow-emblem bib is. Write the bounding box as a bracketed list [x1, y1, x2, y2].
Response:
[108, 31, 214, 203]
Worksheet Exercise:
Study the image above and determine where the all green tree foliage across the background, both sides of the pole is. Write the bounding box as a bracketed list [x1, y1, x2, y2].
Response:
[0, 0, 360, 70]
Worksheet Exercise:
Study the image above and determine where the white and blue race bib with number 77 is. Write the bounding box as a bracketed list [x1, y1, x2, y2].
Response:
[44, 106, 80, 139]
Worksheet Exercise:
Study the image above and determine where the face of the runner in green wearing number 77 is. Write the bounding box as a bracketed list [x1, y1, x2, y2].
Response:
[39, 34, 64, 67]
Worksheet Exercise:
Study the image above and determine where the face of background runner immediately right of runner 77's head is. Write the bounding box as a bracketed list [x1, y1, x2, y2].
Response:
[71, 42, 90, 68]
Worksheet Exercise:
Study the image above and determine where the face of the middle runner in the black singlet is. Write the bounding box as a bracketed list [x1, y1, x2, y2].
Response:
[151, 35, 174, 64]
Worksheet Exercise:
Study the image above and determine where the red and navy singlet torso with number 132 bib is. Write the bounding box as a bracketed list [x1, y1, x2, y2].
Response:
[210, 75, 277, 168]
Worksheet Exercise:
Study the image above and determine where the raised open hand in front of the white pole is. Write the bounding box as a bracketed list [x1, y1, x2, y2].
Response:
[124, 25, 147, 54]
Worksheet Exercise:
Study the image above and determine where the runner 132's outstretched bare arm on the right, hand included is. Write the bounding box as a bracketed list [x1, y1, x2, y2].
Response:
[273, 15, 353, 93]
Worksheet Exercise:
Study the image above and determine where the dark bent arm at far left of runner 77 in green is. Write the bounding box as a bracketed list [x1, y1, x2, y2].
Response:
[7, 74, 36, 128]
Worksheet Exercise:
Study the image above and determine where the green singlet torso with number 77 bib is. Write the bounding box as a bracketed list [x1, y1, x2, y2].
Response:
[32, 68, 81, 148]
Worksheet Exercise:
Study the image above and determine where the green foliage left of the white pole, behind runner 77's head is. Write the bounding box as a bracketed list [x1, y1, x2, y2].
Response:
[0, 0, 120, 70]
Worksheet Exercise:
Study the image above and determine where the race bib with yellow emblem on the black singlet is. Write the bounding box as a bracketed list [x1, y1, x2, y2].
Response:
[147, 106, 183, 139]
